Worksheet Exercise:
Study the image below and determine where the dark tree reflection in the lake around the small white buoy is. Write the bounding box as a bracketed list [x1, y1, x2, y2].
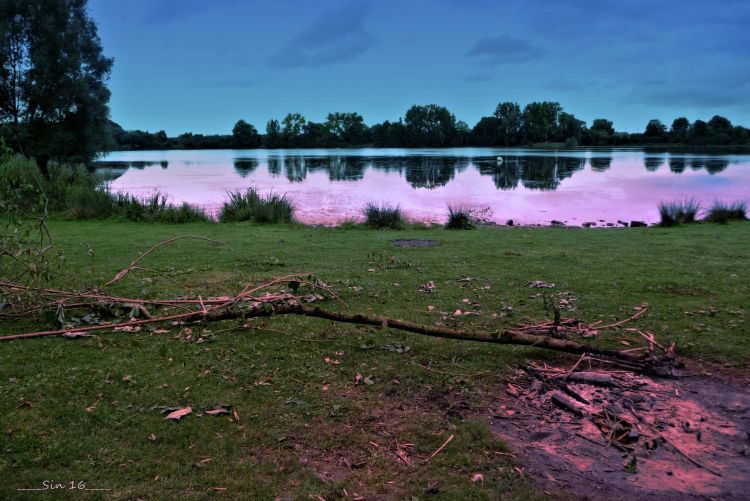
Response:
[475, 156, 586, 190]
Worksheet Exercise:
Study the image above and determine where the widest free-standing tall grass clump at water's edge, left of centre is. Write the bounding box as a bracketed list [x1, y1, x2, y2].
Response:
[219, 188, 294, 224]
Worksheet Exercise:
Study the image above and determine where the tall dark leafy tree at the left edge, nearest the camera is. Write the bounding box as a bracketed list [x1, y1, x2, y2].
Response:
[0, 0, 113, 175]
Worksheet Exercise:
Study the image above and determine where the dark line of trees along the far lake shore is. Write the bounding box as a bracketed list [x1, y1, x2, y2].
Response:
[110, 101, 750, 150]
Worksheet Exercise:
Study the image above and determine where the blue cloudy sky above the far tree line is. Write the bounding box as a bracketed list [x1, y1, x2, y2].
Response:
[89, 0, 750, 135]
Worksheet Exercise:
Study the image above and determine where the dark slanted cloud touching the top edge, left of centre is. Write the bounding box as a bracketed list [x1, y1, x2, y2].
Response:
[271, 1, 375, 68]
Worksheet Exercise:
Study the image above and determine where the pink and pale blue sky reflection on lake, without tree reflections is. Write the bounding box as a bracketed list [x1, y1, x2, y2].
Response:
[104, 149, 750, 224]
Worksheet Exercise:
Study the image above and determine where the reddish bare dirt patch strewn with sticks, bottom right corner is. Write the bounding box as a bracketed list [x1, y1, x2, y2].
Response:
[490, 368, 750, 500]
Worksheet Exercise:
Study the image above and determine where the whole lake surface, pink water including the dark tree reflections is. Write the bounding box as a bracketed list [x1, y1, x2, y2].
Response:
[95, 148, 750, 225]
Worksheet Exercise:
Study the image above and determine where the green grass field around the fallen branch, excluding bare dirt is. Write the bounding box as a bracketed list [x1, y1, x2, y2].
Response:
[0, 221, 750, 500]
